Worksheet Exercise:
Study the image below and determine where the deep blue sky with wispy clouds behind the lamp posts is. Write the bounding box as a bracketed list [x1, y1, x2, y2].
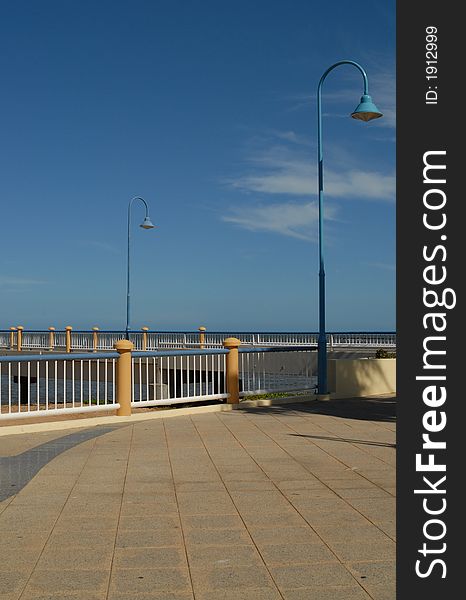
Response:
[0, 0, 395, 331]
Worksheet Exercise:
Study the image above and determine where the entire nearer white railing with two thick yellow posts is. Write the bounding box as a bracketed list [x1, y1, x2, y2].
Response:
[0, 338, 315, 420]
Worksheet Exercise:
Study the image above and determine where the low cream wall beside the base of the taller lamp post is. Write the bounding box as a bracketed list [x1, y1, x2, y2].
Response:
[328, 358, 396, 398]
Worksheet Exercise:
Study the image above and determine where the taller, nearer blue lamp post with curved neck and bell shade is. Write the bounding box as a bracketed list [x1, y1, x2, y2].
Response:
[317, 60, 382, 395]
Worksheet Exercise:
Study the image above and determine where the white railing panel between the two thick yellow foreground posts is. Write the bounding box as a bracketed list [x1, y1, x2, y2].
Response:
[132, 349, 228, 407]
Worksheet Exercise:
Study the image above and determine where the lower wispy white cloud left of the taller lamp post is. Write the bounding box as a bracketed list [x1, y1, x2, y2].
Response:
[222, 202, 336, 241]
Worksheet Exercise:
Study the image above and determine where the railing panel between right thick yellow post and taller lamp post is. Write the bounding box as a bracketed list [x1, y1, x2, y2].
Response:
[239, 346, 317, 397]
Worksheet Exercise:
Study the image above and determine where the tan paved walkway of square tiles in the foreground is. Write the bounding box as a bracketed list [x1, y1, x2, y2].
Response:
[0, 399, 395, 600]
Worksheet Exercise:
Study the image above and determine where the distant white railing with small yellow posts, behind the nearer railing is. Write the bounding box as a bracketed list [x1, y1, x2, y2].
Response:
[0, 326, 396, 352]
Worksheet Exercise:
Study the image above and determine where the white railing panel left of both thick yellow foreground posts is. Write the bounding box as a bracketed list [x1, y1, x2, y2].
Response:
[0, 352, 119, 419]
